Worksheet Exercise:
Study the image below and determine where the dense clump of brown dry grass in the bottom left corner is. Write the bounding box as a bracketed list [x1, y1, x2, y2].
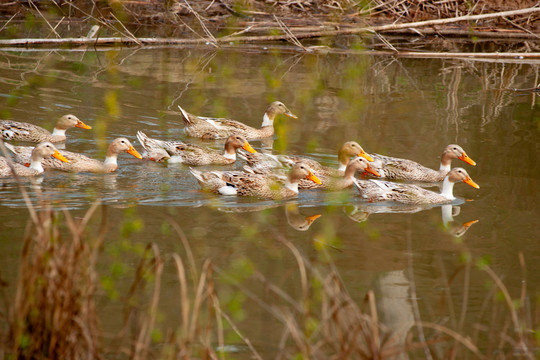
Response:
[8, 205, 106, 359]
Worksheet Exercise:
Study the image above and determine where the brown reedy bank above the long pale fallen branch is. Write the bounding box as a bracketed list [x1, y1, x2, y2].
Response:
[0, 0, 540, 40]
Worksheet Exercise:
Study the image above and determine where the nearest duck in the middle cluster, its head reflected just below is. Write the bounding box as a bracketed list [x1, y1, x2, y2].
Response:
[190, 163, 320, 200]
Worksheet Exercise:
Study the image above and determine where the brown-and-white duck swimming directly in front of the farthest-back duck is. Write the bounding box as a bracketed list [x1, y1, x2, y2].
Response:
[137, 131, 257, 166]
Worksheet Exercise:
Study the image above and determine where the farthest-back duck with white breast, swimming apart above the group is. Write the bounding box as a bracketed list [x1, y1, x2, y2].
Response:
[178, 101, 298, 140]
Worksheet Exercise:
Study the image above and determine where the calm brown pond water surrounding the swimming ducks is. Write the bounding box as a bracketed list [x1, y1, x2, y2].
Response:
[0, 43, 540, 357]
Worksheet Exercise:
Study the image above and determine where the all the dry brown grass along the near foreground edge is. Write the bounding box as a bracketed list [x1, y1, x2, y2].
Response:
[2, 198, 535, 360]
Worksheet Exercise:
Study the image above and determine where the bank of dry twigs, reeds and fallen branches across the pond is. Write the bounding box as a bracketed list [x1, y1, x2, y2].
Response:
[0, 0, 540, 48]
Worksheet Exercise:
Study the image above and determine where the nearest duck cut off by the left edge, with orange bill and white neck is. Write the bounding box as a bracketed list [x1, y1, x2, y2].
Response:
[0, 141, 68, 177]
